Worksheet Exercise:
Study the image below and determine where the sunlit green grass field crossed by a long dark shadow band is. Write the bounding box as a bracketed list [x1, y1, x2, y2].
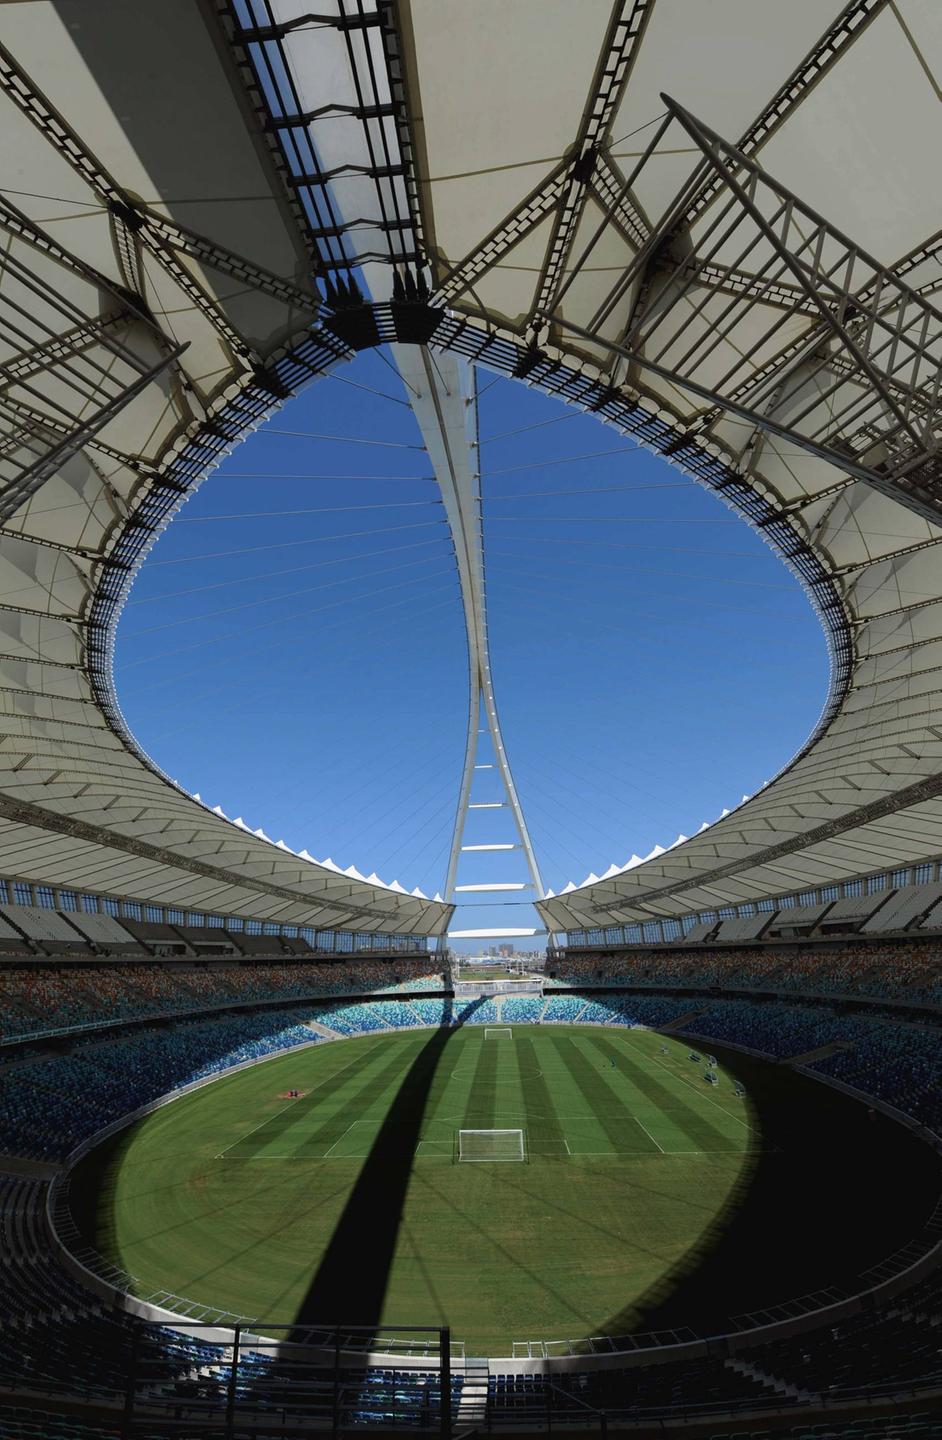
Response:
[73, 1025, 939, 1354]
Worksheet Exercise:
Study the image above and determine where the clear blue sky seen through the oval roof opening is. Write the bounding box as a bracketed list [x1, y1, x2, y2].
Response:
[115, 351, 827, 929]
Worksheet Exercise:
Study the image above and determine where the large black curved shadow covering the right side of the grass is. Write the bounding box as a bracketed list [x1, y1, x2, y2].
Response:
[596, 1044, 939, 1336]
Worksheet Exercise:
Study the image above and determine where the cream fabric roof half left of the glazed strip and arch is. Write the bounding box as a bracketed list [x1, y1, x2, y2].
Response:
[0, 0, 449, 933]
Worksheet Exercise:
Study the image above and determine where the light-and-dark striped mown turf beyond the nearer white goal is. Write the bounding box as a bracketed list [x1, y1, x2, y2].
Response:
[216, 1025, 750, 1164]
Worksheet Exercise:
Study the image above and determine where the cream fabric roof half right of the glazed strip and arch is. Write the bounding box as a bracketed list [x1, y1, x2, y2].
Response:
[388, 0, 942, 930]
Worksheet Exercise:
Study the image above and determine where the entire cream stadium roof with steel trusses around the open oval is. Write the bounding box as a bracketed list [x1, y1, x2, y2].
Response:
[0, 0, 942, 933]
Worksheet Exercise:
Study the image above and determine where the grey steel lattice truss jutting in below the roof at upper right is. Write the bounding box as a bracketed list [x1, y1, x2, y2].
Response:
[546, 96, 942, 521]
